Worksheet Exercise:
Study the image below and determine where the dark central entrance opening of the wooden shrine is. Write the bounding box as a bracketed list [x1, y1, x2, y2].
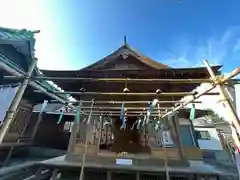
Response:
[112, 117, 150, 153]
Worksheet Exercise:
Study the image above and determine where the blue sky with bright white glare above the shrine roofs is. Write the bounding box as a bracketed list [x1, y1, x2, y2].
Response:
[0, 0, 240, 72]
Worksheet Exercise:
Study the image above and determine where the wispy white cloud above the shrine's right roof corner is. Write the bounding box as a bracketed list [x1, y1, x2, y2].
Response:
[161, 27, 240, 67]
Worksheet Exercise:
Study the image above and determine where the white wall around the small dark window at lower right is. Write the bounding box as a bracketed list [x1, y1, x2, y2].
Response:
[194, 127, 223, 150]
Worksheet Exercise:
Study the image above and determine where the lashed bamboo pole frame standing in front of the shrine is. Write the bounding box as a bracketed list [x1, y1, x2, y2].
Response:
[0, 56, 240, 180]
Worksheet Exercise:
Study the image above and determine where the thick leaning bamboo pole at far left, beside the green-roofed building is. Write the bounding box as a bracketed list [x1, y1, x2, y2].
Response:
[0, 58, 37, 144]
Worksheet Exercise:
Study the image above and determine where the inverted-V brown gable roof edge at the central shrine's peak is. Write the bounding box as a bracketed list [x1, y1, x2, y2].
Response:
[81, 44, 170, 70]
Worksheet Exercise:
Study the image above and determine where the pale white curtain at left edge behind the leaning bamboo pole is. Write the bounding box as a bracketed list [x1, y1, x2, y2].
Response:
[0, 85, 19, 123]
